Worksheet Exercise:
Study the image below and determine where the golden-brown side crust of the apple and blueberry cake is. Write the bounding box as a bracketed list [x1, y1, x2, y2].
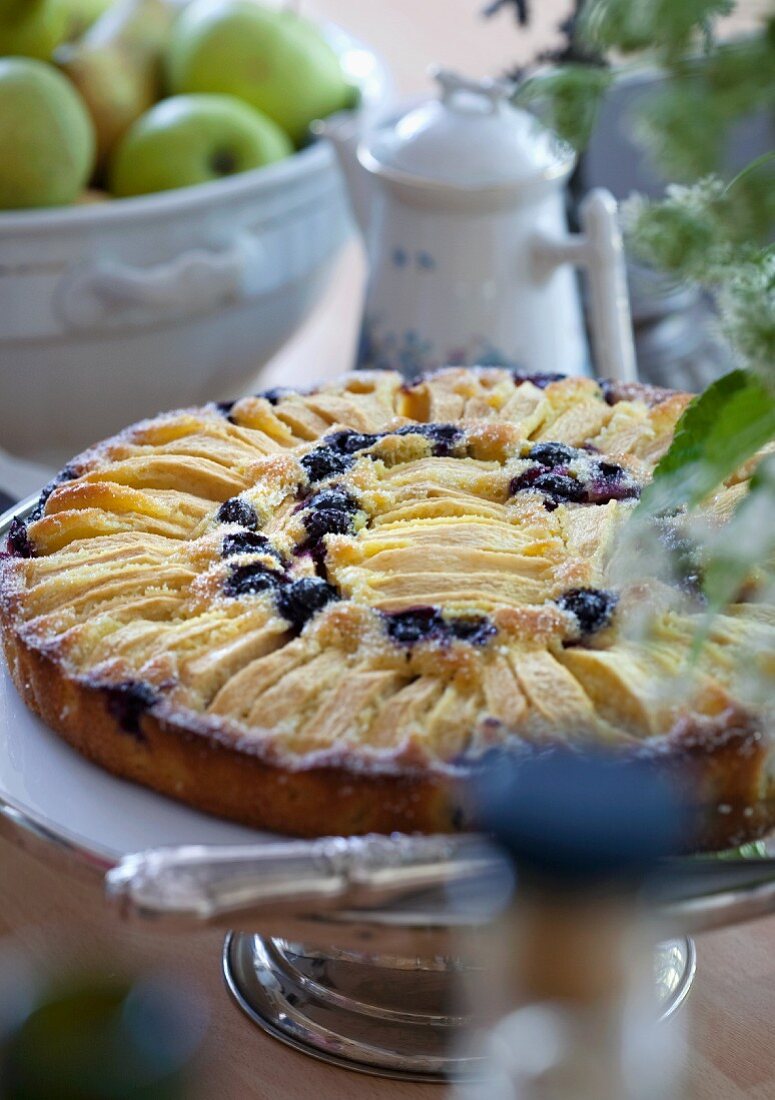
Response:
[2, 611, 775, 853]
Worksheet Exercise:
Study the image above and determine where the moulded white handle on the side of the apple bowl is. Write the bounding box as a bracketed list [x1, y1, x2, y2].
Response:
[58, 234, 263, 331]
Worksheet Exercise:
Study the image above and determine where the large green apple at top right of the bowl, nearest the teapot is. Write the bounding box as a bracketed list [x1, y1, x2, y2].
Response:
[168, 0, 352, 143]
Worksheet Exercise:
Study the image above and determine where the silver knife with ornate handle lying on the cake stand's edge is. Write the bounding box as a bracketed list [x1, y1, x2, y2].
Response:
[106, 835, 775, 946]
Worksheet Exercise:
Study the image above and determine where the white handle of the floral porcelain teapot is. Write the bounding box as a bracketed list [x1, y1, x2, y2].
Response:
[533, 187, 638, 382]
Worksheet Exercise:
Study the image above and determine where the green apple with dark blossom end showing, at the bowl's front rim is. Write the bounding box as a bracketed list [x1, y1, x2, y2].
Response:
[110, 96, 294, 198]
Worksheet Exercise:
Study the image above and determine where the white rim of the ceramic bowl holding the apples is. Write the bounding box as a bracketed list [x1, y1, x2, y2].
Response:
[0, 21, 392, 238]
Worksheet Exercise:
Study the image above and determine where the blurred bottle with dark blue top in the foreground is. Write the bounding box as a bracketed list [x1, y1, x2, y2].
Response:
[454, 751, 685, 1100]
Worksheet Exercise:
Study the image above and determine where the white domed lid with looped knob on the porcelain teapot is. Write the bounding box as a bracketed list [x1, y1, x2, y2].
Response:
[358, 69, 575, 189]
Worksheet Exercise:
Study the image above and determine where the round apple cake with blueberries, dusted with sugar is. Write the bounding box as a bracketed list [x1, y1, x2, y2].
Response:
[0, 367, 775, 848]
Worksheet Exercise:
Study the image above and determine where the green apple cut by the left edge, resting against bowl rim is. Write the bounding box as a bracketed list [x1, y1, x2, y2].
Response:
[0, 57, 95, 210]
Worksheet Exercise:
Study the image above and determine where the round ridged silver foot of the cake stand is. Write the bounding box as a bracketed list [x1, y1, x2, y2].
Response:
[218, 933, 697, 1081]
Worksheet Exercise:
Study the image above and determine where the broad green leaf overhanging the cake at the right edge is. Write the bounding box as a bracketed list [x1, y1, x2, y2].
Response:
[640, 370, 775, 513]
